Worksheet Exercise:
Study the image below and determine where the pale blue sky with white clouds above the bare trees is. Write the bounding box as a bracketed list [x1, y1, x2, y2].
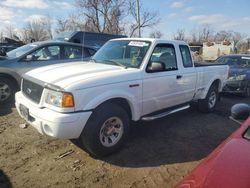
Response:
[0, 0, 250, 37]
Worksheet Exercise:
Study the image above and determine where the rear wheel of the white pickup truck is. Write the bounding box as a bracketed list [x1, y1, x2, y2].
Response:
[198, 84, 219, 113]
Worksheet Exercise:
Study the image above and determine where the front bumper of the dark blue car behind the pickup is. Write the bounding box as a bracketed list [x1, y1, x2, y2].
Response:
[223, 80, 247, 94]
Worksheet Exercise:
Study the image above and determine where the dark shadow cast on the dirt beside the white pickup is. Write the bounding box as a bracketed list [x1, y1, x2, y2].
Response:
[102, 96, 250, 168]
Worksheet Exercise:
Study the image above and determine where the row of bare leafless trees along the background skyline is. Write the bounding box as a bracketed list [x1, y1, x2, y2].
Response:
[0, 0, 247, 53]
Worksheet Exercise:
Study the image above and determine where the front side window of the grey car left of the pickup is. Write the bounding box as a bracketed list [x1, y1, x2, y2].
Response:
[30, 46, 60, 61]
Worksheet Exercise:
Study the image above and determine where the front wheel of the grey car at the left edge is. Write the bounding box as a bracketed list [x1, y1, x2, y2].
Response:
[0, 77, 17, 104]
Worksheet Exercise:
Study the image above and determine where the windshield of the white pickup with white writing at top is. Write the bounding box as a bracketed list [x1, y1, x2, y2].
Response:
[92, 40, 150, 68]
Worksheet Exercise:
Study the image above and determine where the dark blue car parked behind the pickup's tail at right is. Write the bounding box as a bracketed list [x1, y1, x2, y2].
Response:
[215, 54, 250, 97]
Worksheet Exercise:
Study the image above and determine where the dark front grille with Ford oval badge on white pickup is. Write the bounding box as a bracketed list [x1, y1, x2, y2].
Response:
[22, 79, 43, 103]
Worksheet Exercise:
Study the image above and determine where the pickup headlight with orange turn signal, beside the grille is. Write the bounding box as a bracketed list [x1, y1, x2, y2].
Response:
[45, 90, 75, 108]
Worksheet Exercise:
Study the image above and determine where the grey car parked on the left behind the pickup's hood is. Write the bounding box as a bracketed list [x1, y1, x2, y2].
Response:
[0, 41, 96, 104]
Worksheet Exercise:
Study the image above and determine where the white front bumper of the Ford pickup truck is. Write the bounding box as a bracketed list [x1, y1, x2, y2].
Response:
[15, 91, 92, 139]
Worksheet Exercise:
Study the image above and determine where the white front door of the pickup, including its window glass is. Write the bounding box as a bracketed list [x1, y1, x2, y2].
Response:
[142, 43, 181, 115]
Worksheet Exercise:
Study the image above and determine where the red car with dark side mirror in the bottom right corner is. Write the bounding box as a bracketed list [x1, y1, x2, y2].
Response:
[176, 104, 250, 188]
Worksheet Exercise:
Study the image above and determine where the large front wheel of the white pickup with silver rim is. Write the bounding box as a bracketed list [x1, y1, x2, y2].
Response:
[80, 103, 130, 158]
